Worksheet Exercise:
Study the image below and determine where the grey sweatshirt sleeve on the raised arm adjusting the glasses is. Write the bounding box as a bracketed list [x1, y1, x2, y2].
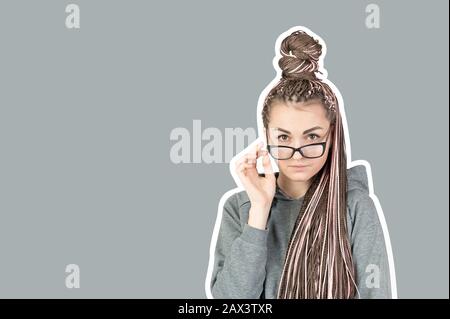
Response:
[211, 195, 268, 299]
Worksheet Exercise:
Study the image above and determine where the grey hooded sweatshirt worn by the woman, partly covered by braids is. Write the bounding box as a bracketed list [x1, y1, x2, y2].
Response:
[210, 165, 392, 299]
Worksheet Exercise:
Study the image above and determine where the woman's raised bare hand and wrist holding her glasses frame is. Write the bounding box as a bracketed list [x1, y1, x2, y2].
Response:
[236, 142, 276, 228]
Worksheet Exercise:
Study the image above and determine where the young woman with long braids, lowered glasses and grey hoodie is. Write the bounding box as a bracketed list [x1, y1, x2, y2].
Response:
[210, 31, 391, 299]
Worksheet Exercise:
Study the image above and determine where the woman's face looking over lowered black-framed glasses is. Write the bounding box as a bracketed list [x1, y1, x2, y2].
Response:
[266, 100, 331, 182]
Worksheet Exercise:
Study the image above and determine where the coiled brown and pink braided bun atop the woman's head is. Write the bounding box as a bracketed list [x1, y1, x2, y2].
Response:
[278, 31, 322, 79]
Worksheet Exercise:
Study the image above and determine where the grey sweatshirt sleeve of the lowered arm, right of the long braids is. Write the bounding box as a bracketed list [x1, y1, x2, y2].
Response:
[351, 194, 392, 299]
